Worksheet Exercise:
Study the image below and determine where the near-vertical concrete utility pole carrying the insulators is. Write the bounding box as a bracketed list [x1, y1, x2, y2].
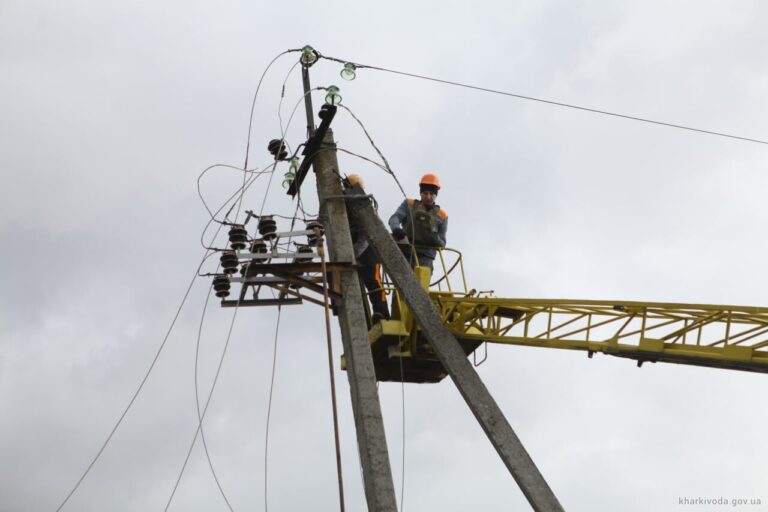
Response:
[313, 128, 397, 512]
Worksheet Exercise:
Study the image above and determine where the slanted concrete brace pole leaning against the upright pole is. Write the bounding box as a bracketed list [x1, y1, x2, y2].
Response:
[350, 198, 563, 512]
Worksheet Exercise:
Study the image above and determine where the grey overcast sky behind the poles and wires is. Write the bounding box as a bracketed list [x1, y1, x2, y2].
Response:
[0, 0, 768, 512]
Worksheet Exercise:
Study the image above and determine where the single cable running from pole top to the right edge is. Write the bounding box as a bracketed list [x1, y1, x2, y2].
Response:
[318, 53, 768, 144]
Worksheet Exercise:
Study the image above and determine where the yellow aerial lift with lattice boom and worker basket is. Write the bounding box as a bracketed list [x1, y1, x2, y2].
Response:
[370, 250, 768, 382]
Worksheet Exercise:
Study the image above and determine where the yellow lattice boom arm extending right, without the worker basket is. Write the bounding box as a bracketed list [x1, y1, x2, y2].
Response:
[433, 294, 768, 372]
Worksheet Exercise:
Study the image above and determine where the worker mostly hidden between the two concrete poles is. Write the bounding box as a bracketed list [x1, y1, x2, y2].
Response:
[344, 174, 389, 324]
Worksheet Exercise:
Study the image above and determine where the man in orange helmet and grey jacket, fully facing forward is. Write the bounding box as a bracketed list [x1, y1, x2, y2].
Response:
[389, 174, 448, 270]
